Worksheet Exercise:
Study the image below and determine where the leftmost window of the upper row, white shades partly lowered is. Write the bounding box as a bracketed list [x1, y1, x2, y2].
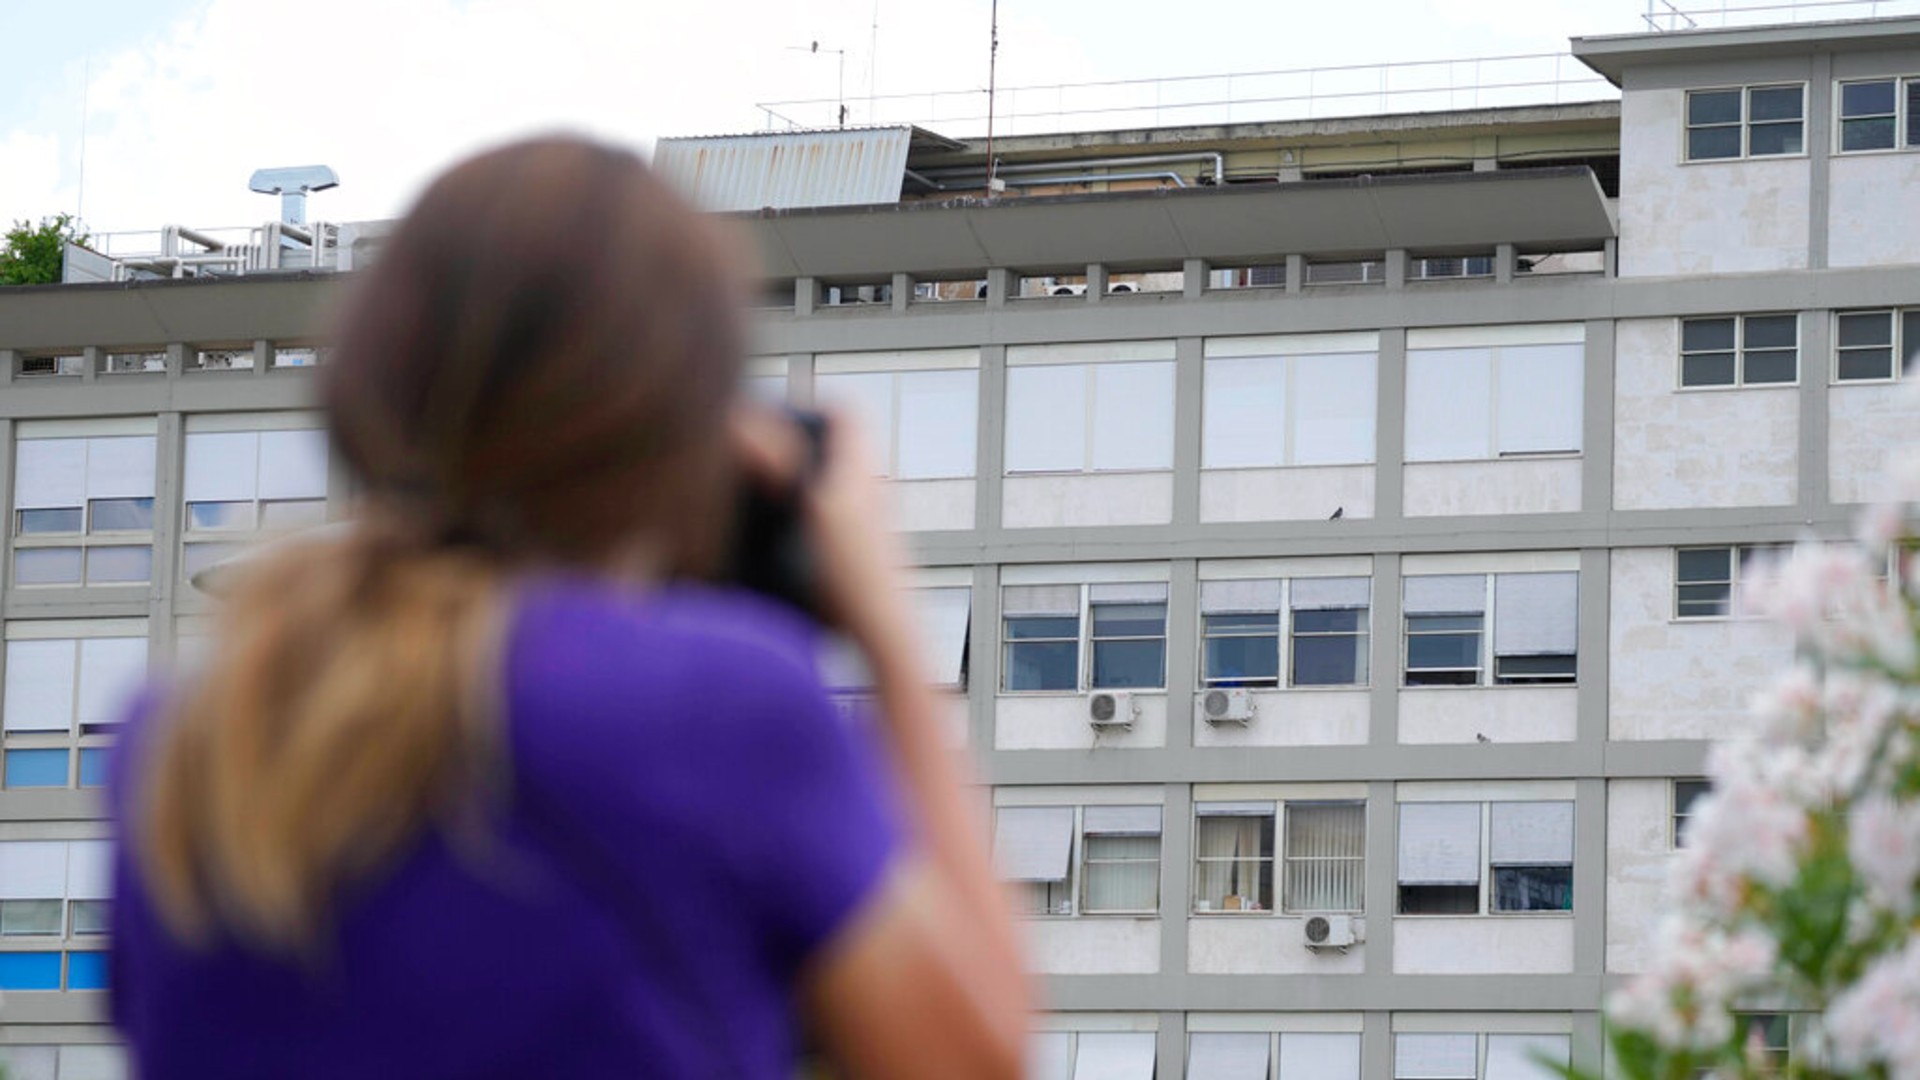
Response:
[13, 425, 156, 588]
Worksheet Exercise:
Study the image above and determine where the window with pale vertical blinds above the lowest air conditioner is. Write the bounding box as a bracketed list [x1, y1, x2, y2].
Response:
[1192, 799, 1367, 915]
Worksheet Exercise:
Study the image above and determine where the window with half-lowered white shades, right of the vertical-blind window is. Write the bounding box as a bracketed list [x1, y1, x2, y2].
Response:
[1398, 801, 1572, 915]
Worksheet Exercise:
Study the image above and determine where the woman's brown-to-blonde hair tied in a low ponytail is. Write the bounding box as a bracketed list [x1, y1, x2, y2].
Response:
[134, 138, 743, 953]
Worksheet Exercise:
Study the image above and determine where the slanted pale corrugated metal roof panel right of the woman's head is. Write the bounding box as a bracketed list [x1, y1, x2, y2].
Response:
[653, 127, 914, 211]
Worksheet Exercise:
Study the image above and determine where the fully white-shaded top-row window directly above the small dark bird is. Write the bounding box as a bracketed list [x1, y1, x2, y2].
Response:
[1200, 340, 1379, 469]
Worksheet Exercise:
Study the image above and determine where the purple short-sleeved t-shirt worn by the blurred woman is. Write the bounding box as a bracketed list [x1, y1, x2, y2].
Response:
[111, 582, 897, 1080]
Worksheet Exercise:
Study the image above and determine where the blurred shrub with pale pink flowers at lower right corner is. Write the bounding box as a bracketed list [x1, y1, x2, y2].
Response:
[1569, 449, 1920, 1080]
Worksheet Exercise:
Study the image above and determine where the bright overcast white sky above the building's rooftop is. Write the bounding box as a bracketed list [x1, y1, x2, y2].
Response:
[0, 0, 1766, 233]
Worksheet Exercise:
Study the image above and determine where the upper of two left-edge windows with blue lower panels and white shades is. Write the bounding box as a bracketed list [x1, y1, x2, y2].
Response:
[0, 619, 148, 790]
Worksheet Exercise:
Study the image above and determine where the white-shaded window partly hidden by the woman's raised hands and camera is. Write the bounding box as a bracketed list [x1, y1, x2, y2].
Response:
[814, 369, 979, 480]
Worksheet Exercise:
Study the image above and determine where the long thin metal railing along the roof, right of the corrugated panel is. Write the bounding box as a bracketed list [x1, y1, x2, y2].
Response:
[756, 52, 1619, 136]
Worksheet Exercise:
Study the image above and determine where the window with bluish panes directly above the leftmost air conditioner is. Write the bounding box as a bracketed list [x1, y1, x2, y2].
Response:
[1000, 582, 1167, 692]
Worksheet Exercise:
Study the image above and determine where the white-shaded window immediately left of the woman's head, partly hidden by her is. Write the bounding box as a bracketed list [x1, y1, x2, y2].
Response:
[182, 429, 326, 577]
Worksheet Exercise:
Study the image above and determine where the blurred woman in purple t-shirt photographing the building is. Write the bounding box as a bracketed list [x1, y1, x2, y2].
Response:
[113, 138, 1027, 1080]
